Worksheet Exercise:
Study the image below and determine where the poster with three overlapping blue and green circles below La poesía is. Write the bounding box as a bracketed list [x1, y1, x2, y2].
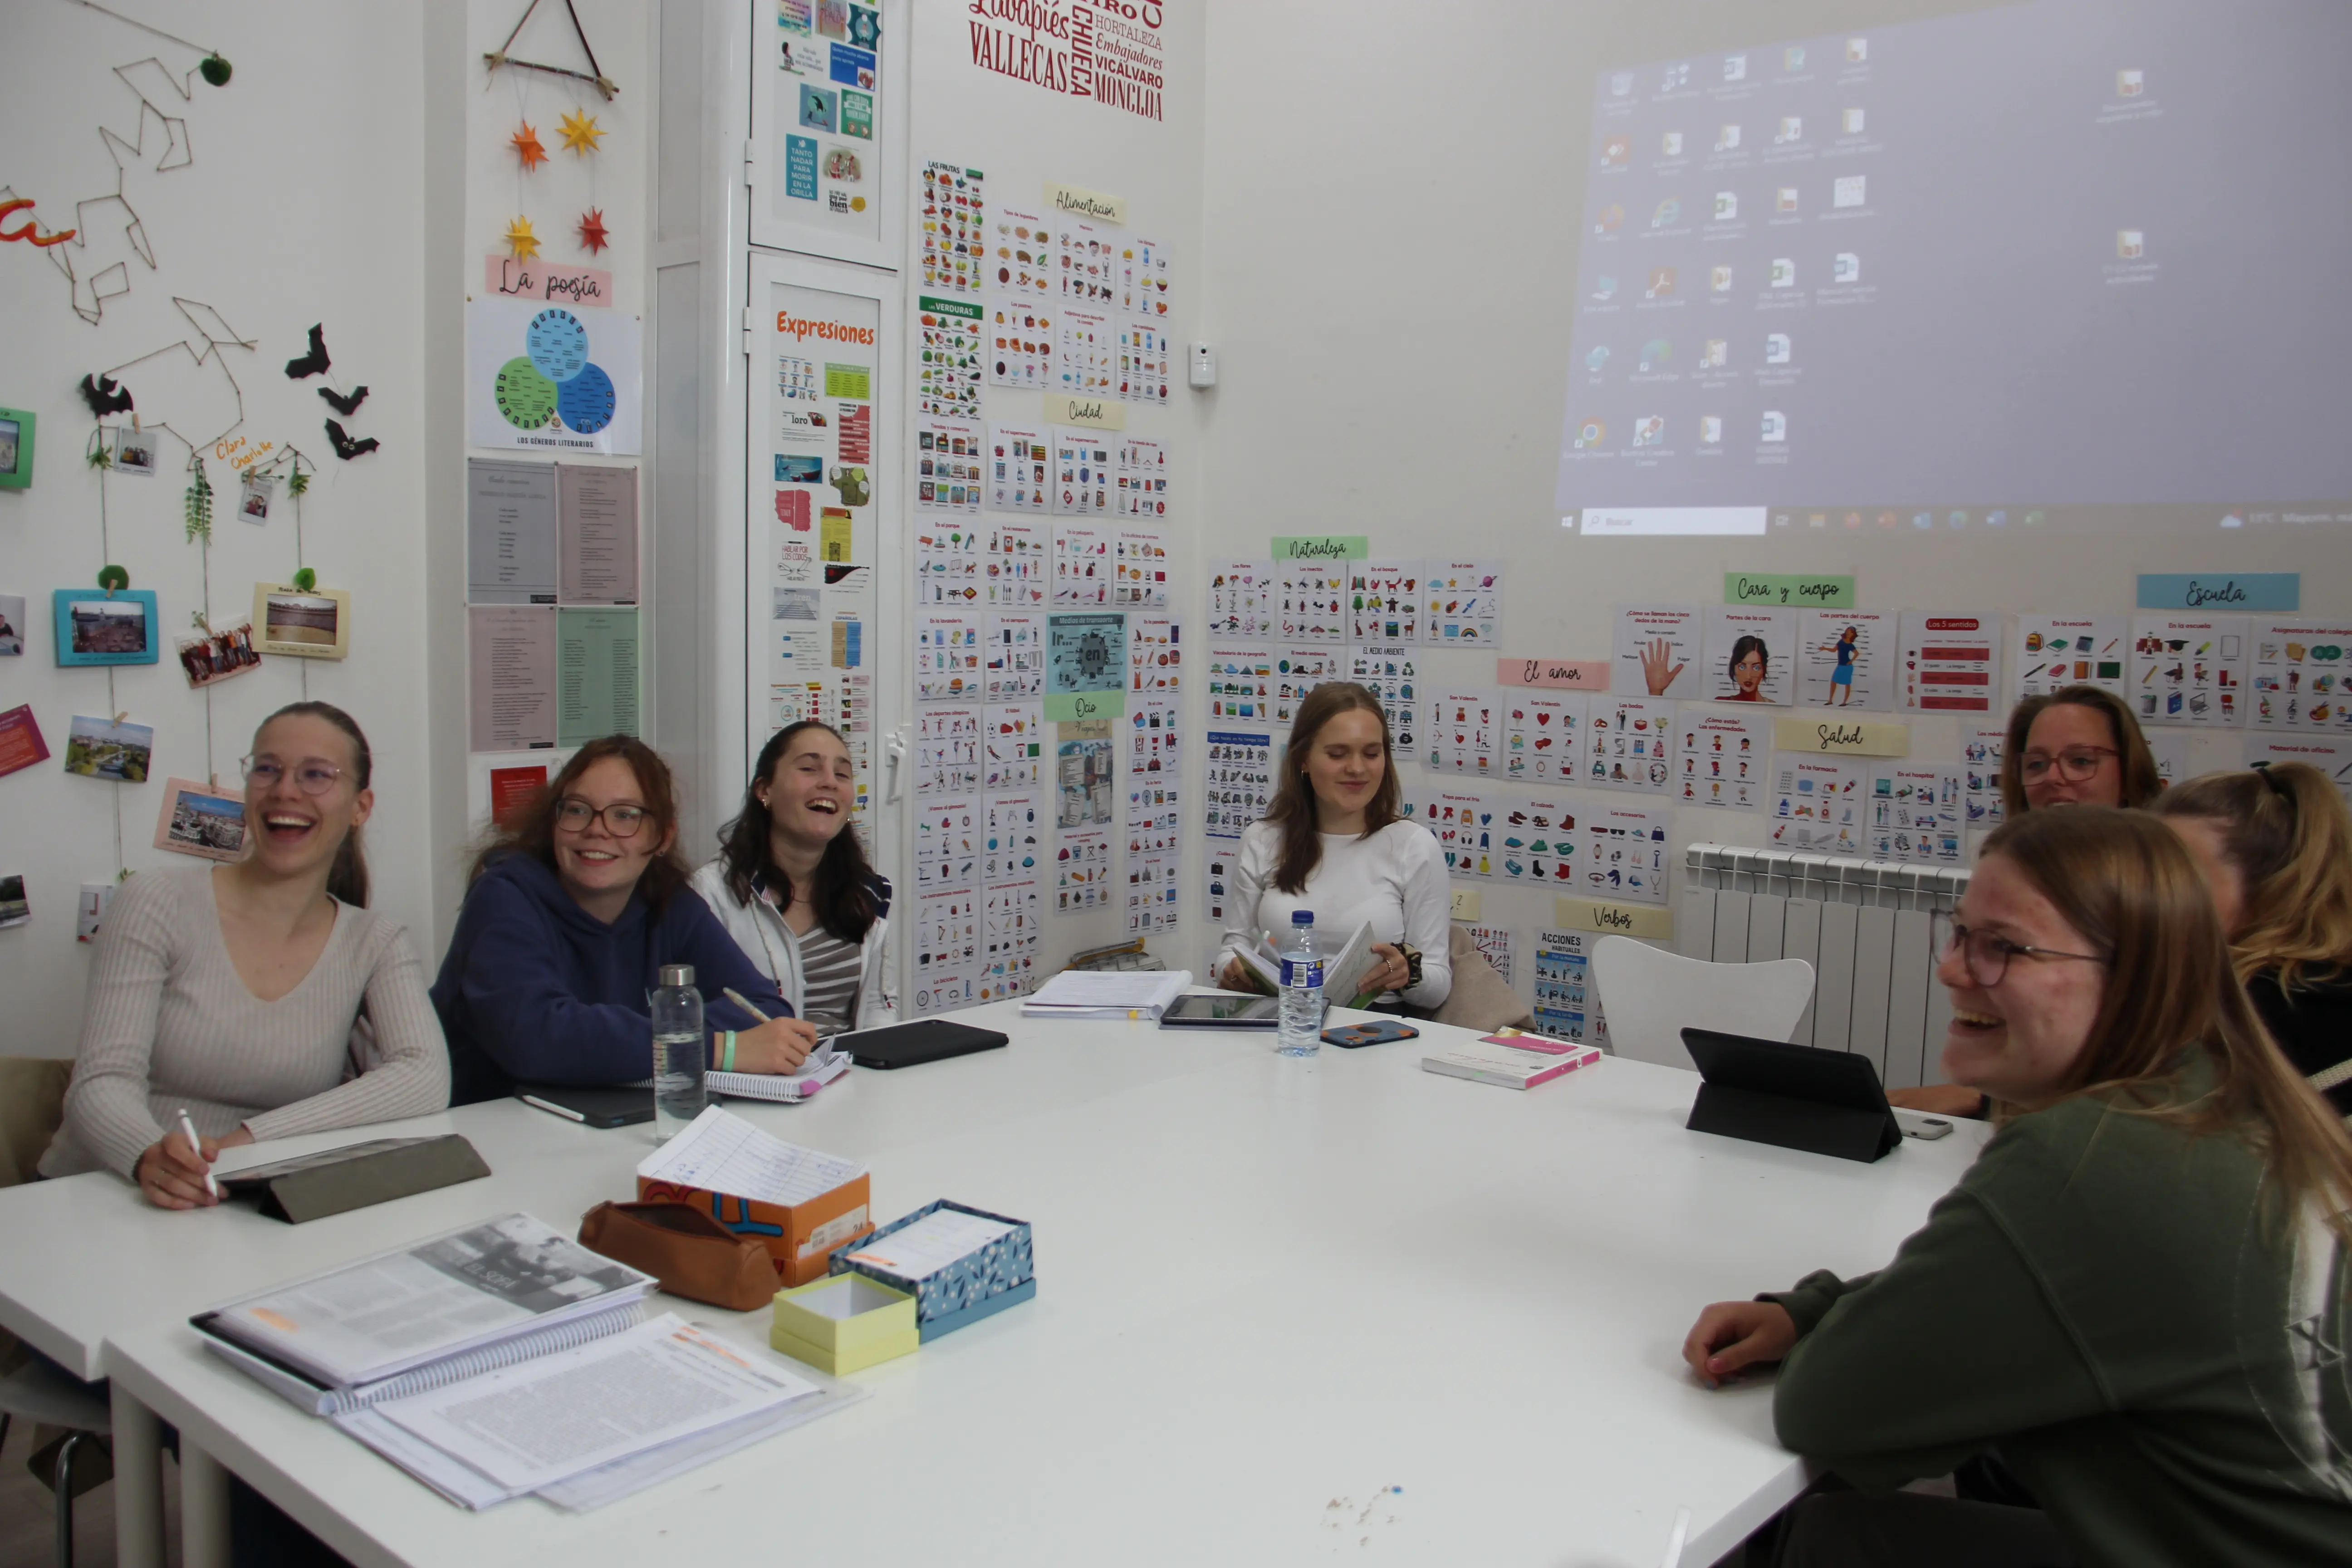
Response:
[466, 299, 644, 456]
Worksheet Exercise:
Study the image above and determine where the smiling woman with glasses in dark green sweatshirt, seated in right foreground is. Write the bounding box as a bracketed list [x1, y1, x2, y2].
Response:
[1684, 806, 2352, 1568]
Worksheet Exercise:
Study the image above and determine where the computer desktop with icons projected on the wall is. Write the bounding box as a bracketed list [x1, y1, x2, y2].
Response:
[1559, 0, 2352, 534]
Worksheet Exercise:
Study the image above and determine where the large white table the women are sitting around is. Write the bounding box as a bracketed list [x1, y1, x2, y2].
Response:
[0, 1006, 1983, 1568]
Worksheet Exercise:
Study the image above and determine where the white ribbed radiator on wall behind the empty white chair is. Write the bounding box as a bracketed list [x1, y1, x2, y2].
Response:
[1675, 844, 1969, 1088]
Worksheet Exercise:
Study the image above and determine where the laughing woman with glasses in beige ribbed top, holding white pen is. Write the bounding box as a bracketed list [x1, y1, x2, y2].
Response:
[40, 703, 449, 1208]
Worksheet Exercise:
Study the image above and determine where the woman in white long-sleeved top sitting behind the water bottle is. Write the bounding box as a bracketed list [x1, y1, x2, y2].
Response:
[1218, 682, 1454, 1009]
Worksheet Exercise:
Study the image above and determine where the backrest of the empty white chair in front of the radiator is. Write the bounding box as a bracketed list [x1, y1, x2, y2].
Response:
[1592, 936, 1813, 1070]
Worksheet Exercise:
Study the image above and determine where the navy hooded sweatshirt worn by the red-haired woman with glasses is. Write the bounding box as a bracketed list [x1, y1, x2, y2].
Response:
[433, 853, 793, 1105]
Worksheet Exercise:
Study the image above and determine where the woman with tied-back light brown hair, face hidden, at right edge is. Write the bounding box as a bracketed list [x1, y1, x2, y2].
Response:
[2157, 762, 2352, 1117]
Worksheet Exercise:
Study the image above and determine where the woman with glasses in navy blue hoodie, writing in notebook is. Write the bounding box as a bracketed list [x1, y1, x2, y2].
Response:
[433, 736, 816, 1105]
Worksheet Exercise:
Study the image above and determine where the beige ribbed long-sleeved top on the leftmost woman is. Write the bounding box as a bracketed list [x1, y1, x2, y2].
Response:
[40, 865, 449, 1176]
